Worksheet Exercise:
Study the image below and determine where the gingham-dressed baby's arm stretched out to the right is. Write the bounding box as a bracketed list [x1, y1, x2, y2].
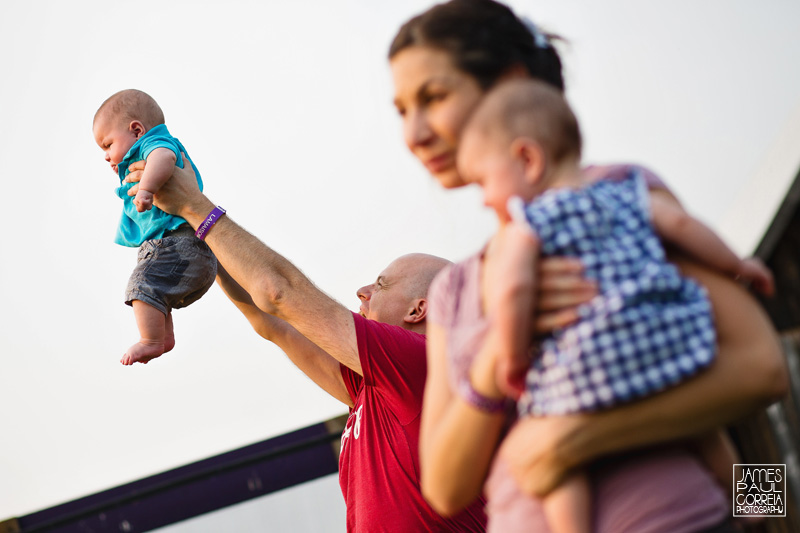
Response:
[650, 191, 774, 295]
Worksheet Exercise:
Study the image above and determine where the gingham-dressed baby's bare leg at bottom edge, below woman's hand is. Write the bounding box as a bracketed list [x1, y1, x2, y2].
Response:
[542, 472, 592, 533]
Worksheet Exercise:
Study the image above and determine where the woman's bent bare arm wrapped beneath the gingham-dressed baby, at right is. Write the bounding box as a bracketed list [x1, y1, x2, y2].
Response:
[500, 258, 788, 495]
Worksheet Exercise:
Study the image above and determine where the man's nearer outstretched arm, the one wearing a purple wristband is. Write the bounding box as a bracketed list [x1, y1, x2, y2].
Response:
[128, 157, 361, 374]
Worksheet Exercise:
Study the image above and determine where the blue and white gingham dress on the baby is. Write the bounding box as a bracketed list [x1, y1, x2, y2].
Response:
[518, 170, 716, 415]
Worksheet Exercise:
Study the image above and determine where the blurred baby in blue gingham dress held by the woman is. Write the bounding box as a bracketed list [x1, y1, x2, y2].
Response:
[450, 80, 772, 532]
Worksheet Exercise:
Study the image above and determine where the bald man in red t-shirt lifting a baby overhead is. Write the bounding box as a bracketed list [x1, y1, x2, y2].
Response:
[137, 165, 486, 532]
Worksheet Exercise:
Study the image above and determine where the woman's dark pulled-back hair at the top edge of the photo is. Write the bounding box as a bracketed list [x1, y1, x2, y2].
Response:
[389, 0, 564, 91]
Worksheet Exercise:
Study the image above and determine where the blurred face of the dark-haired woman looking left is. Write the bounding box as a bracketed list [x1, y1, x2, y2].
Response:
[390, 46, 484, 189]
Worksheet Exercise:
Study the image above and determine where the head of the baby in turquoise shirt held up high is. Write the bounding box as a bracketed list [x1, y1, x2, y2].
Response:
[92, 89, 164, 172]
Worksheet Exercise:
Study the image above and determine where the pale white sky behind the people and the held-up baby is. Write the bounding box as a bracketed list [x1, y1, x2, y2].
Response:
[0, 0, 800, 519]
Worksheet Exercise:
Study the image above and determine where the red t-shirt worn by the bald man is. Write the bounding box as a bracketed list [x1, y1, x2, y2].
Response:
[339, 313, 486, 533]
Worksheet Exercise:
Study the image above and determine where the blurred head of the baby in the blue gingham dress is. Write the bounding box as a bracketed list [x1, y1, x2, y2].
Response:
[458, 79, 581, 220]
